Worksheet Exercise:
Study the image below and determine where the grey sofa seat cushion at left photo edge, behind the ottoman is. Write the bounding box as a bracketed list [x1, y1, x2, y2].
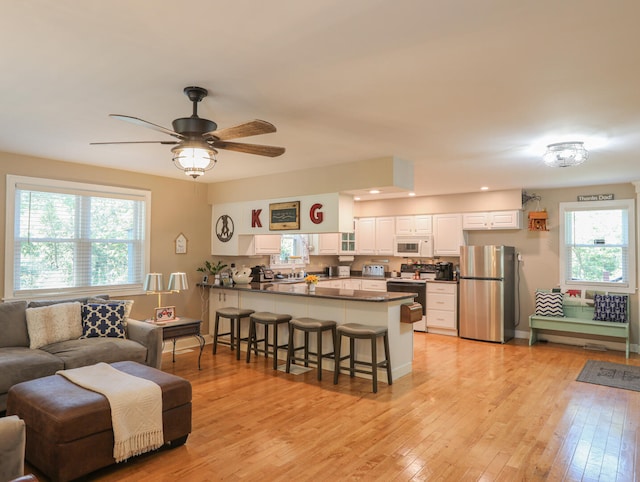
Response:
[0, 347, 64, 396]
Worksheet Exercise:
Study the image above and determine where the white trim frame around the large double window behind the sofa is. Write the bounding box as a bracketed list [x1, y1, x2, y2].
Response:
[3, 174, 151, 301]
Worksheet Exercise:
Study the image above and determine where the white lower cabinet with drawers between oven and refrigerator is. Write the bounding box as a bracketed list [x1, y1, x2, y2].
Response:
[427, 282, 458, 336]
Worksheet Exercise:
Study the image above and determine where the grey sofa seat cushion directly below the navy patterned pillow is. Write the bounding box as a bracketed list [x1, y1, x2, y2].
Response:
[41, 338, 147, 369]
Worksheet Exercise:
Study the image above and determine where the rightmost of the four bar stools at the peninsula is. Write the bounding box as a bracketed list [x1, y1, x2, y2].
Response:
[333, 323, 393, 393]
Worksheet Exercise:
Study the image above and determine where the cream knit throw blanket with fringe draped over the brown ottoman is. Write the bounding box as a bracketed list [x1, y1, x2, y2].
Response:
[57, 363, 164, 462]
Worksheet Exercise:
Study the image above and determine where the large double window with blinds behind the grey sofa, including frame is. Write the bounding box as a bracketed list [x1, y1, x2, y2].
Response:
[5, 176, 151, 298]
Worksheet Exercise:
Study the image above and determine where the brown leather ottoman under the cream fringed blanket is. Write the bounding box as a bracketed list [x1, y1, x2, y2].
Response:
[7, 362, 191, 480]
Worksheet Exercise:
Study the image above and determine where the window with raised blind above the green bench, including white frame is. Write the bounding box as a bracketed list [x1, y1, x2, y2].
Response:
[560, 199, 636, 292]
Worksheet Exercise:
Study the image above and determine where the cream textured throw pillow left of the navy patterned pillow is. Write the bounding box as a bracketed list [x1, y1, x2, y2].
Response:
[27, 302, 82, 349]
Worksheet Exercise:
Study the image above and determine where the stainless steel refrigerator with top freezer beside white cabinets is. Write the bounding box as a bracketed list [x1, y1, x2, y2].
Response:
[459, 246, 516, 343]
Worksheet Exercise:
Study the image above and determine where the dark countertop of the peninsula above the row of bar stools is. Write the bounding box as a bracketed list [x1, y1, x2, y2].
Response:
[198, 278, 417, 302]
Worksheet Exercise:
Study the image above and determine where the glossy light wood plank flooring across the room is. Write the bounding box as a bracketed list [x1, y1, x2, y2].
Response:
[28, 333, 640, 481]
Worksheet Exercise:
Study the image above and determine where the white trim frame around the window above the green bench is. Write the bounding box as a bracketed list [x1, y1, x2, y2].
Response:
[558, 199, 636, 293]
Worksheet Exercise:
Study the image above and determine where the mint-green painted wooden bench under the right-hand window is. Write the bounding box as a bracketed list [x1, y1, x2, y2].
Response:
[529, 305, 629, 358]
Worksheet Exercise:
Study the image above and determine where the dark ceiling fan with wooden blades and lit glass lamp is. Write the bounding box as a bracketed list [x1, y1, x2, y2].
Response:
[91, 87, 285, 179]
